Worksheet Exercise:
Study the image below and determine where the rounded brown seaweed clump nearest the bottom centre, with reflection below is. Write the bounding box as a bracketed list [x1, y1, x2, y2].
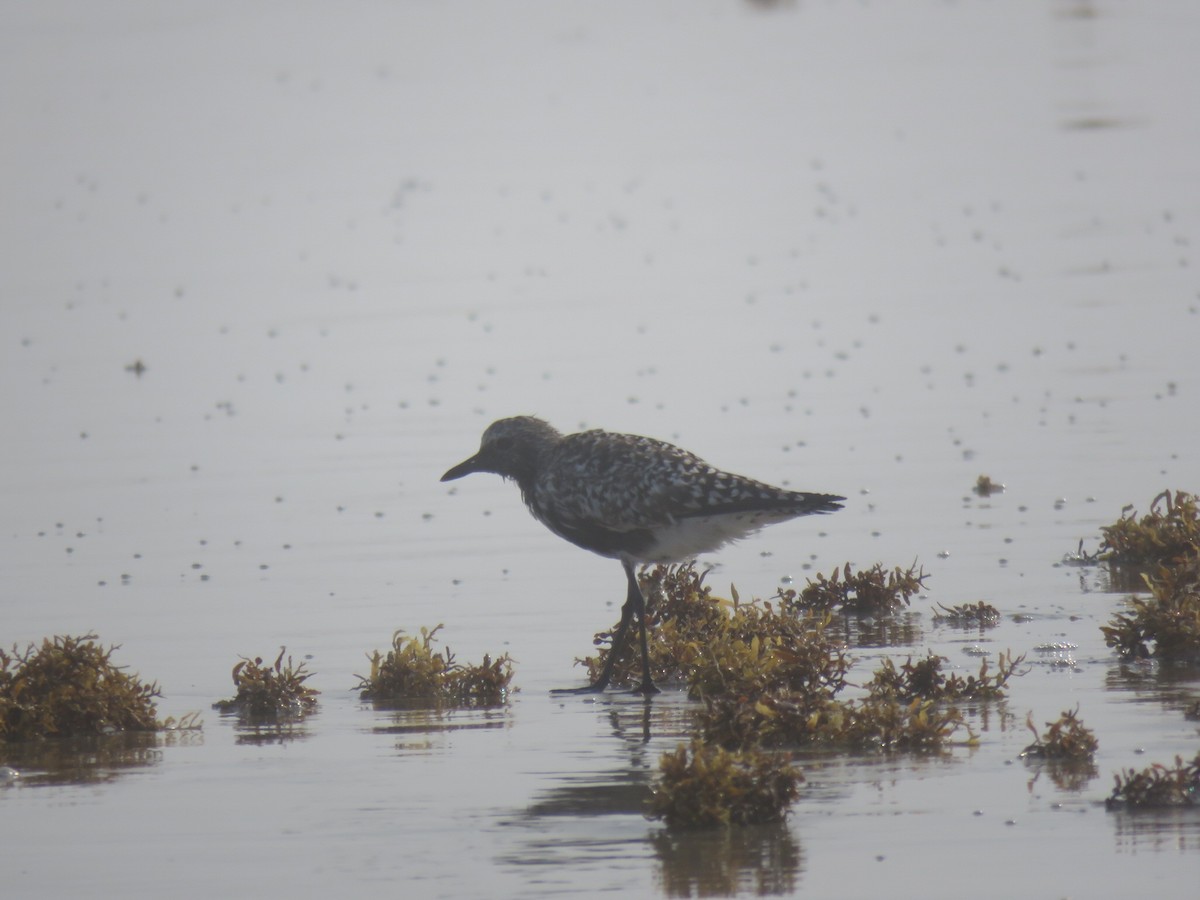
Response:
[650, 740, 804, 828]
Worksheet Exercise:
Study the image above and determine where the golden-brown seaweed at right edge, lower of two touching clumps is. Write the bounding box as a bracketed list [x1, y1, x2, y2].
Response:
[1100, 557, 1200, 660]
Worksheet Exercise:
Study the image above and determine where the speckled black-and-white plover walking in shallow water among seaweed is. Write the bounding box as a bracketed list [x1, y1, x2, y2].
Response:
[442, 415, 846, 694]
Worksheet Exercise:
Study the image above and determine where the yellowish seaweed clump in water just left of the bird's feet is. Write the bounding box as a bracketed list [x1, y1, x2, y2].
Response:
[355, 625, 512, 707]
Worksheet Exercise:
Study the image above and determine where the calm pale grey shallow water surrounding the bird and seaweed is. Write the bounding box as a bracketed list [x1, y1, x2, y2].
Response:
[0, 0, 1200, 898]
